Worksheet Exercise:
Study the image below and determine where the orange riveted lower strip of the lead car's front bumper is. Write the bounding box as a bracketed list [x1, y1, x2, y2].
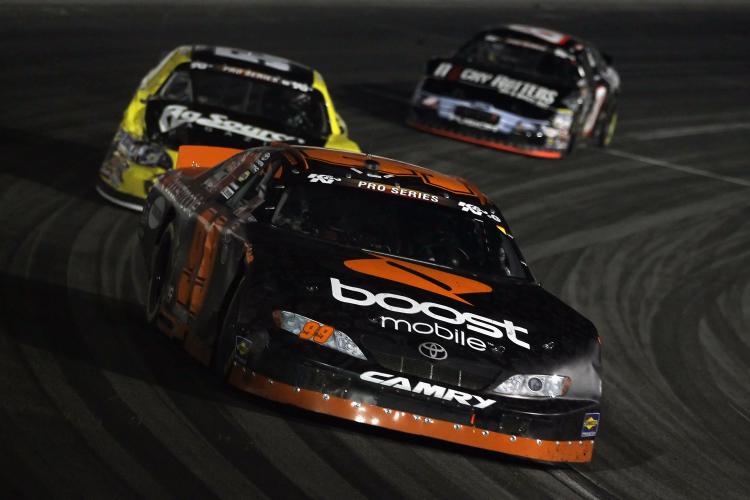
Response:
[229, 366, 594, 462]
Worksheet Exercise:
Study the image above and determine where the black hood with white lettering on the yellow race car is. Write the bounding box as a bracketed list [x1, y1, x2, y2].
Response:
[146, 99, 325, 149]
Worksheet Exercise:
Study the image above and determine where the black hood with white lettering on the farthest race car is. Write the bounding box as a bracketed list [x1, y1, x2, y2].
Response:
[426, 59, 576, 119]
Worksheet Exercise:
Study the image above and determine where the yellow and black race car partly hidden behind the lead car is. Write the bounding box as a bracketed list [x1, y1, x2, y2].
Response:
[97, 45, 360, 210]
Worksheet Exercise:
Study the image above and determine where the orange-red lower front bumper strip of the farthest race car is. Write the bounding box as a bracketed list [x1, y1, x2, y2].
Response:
[406, 108, 564, 159]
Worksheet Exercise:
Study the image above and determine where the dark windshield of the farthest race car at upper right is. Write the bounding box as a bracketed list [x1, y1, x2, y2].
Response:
[459, 40, 580, 85]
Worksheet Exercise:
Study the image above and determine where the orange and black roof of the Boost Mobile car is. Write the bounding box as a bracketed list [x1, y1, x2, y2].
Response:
[280, 146, 490, 205]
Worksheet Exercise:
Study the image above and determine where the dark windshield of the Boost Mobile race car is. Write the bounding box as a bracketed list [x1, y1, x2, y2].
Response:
[271, 184, 530, 279]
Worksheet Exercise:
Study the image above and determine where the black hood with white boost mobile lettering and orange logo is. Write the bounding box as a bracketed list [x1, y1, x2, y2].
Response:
[262, 229, 600, 399]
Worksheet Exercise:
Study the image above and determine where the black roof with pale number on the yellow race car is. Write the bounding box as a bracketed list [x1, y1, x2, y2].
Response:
[192, 45, 315, 85]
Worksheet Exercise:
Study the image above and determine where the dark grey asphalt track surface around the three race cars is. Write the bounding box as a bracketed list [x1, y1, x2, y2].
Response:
[0, 4, 750, 498]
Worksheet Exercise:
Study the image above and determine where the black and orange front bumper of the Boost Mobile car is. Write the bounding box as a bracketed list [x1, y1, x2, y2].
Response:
[229, 334, 599, 462]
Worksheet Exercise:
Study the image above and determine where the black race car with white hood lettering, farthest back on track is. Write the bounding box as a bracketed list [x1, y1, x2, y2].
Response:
[407, 24, 620, 158]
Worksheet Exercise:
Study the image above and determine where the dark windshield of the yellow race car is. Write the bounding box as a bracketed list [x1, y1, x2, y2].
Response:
[160, 70, 329, 137]
